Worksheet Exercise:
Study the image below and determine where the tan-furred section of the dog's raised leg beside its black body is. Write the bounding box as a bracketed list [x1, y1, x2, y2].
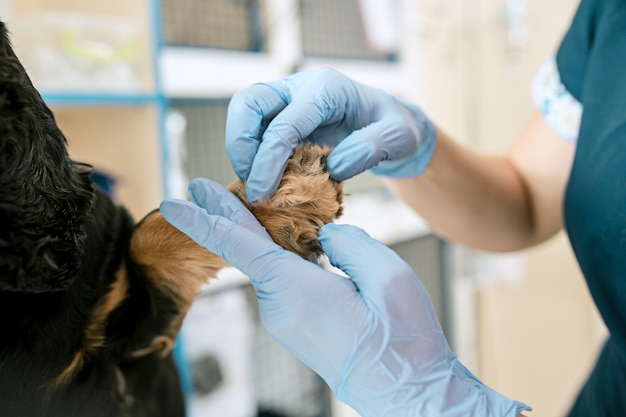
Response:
[125, 210, 228, 356]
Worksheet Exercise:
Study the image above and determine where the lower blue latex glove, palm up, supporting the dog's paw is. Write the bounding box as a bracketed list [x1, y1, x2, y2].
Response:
[161, 180, 528, 417]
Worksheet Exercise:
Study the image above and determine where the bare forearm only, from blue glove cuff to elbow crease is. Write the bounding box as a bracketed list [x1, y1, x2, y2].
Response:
[385, 127, 535, 251]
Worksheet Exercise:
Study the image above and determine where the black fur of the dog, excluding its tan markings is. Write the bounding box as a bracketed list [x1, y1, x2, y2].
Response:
[0, 22, 184, 417]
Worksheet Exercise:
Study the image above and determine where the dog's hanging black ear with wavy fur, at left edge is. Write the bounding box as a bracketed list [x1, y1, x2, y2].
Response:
[0, 22, 94, 292]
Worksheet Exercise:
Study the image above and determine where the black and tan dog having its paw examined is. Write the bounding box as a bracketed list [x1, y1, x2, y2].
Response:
[0, 23, 341, 417]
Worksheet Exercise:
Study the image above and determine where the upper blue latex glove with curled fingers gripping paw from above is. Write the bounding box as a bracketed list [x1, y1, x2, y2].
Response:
[226, 68, 437, 201]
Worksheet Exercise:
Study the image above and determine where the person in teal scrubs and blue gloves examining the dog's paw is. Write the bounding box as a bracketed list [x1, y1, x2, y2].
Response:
[162, 0, 626, 417]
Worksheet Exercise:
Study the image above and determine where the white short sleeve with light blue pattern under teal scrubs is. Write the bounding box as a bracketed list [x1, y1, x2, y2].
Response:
[532, 58, 583, 143]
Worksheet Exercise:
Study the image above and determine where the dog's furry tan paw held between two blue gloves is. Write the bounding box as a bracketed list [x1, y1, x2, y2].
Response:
[228, 143, 343, 260]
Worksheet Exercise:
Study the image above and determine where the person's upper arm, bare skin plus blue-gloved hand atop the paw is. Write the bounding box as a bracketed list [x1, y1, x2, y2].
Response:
[226, 69, 574, 251]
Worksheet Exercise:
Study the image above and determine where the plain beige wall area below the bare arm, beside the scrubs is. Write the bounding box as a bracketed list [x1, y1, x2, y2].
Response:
[477, 234, 602, 416]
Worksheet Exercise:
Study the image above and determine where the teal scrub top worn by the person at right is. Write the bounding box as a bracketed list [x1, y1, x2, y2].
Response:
[556, 0, 626, 417]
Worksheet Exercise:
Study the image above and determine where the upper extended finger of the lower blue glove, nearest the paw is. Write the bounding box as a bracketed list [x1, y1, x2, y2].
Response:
[183, 178, 270, 239]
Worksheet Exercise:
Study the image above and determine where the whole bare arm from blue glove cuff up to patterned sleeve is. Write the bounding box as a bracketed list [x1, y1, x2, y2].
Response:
[384, 112, 575, 251]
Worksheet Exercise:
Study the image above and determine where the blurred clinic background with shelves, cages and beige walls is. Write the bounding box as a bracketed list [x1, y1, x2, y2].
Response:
[0, 0, 604, 417]
